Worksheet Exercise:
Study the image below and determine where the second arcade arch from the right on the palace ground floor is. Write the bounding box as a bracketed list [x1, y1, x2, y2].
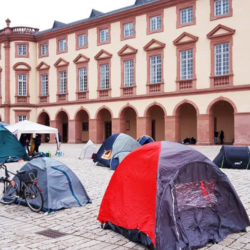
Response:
[174, 100, 199, 142]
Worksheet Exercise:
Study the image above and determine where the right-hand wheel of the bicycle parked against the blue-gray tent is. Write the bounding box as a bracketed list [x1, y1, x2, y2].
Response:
[23, 183, 44, 212]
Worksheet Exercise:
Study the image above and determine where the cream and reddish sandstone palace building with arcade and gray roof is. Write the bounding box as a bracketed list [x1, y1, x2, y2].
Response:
[0, 0, 250, 145]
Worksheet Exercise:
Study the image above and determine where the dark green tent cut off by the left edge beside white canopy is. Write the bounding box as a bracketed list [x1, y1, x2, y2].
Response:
[0, 126, 29, 162]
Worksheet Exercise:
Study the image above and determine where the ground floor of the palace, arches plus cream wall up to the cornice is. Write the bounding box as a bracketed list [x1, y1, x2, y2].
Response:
[0, 92, 250, 145]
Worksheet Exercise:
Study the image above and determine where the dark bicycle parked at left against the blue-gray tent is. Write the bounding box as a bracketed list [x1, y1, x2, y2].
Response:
[0, 157, 44, 212]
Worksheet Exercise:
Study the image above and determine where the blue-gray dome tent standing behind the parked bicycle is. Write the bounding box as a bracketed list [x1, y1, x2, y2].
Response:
[15, 157, 91, 211]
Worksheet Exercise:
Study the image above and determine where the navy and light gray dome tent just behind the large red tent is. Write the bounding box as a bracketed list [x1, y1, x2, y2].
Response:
[93, 133, 141, 170]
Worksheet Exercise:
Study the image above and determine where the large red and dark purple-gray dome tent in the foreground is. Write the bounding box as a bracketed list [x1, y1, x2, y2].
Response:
[98, 141, 250, 250]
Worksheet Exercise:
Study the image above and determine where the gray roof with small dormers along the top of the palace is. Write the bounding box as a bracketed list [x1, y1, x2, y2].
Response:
[35, 0, 160, 36]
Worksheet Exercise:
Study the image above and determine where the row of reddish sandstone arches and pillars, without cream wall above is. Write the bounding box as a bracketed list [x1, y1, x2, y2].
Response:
[31, 94, 250, 145]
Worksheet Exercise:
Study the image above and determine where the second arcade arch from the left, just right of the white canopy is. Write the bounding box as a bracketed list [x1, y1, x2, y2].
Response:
[56, 109, 69, 142]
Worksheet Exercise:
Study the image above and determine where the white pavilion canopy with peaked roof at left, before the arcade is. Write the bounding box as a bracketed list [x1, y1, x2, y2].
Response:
[5, 120, 59, 150]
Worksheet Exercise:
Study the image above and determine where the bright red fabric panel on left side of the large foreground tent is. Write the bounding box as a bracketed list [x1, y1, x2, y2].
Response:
[97, 142, 161, 245]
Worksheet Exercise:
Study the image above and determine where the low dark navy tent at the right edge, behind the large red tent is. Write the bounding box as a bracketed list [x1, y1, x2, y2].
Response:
[213, 146, 250, 170]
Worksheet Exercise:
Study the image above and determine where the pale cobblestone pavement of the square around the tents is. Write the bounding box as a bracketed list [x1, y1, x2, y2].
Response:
[0, 144, 250, 250]
